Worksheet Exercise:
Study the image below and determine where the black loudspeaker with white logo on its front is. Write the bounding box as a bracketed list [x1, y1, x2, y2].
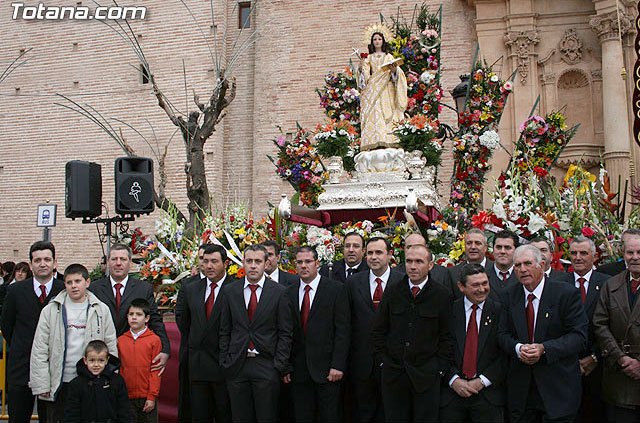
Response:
[114, 157, 155, 214]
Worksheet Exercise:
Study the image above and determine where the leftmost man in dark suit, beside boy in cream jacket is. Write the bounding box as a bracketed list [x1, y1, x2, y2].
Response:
[2, 241, 64, 423]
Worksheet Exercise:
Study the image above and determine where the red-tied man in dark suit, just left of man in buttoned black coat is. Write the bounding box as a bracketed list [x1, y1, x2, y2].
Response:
[344, 237, 403, 423]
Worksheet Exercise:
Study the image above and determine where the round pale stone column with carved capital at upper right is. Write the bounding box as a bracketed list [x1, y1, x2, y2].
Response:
[589, 11, 631, 190]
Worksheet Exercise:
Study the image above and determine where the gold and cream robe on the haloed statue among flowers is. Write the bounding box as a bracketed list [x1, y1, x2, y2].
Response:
[359, 53, 407, 151]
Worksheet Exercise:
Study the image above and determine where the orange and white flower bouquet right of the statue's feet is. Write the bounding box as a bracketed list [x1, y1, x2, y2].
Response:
[393, 114, 443, 166]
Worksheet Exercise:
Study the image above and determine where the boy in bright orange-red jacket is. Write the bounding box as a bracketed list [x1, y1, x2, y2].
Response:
[118, 298, 162, 423]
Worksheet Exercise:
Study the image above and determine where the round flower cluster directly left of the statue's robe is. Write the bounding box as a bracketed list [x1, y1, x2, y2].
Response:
[316, 66, 360, 127]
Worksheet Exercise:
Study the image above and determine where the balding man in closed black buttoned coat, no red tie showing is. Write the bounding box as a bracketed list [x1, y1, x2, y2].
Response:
[371, 246, 452, 423]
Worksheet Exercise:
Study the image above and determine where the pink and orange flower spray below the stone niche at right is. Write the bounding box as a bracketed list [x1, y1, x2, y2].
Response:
[511, 112, 578, 176]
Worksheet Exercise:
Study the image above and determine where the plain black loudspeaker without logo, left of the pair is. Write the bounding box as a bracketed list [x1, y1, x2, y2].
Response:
[64, 160, 102, 219]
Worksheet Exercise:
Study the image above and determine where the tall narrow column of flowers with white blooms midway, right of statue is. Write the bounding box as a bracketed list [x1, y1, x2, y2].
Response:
[450, 63, 513, 214]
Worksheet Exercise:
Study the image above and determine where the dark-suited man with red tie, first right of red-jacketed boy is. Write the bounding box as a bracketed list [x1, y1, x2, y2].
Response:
[176, 244, 233, 423]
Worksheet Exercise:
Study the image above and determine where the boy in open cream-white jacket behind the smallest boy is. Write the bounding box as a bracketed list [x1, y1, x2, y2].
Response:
[29, 264, 117, 423]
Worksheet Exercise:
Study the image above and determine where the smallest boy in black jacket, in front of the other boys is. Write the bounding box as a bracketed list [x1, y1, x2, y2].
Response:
[64, 340, 131, 423]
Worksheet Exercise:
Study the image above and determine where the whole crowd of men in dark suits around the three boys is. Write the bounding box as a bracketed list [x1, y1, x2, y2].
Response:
[2, 229, 640, 423]
